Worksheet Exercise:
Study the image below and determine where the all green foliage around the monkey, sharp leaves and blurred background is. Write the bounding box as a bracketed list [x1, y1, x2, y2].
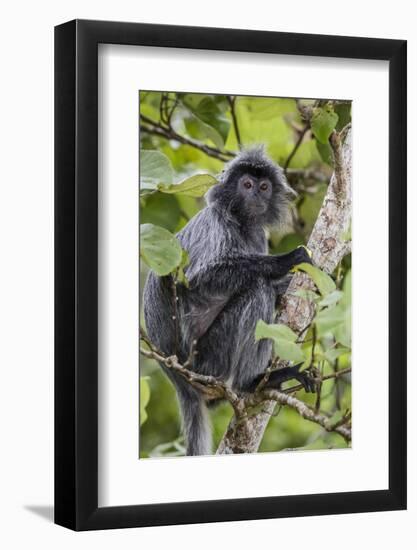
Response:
[139, 92, 351, 457]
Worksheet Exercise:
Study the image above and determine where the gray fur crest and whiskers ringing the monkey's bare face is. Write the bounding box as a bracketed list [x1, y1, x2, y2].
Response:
[206, 145, 296, 230]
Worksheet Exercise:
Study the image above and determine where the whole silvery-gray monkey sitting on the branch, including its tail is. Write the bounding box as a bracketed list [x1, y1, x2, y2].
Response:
[144, 147, 310, 455]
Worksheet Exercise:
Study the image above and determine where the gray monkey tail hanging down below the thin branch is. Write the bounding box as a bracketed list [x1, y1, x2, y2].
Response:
[178, 386, 212, 456]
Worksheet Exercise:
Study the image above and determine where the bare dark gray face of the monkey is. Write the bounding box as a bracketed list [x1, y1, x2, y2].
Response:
[237, 174, 273, 218]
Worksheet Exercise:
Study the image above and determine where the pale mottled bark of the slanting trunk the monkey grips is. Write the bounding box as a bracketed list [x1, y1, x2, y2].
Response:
[217, 128, 352, 454]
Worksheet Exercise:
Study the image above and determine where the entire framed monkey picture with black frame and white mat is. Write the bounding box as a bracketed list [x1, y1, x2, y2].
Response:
[54, 20, 407, 531]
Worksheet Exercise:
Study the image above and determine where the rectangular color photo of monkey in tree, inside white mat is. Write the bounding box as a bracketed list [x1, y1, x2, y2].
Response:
[138, 91, 352, 459]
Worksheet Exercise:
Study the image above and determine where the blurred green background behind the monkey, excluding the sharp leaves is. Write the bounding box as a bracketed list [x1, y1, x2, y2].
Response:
[140, 91, 351, 458]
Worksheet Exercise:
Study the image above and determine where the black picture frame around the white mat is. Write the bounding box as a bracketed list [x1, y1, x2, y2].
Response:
[55, 20, 407, 530]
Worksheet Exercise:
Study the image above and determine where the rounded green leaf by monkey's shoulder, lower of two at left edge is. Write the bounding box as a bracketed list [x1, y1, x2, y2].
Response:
[140, 223, 183, 276]
